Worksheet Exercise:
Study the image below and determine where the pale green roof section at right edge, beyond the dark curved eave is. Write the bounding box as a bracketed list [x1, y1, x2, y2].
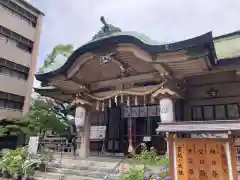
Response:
[214, 34, 240, 59]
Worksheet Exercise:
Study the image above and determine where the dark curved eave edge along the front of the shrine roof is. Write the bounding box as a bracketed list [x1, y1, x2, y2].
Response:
[35, 32, 215, 81]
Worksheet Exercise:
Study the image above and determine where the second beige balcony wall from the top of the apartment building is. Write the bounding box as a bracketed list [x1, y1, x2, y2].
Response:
[0, 37, 31, 67]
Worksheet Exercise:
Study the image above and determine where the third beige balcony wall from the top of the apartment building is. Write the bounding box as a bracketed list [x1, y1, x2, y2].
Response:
[0, 74, 28, 96]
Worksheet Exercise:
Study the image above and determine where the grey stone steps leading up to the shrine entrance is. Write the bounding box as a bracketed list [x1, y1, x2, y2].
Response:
[35, 157, 123, 180]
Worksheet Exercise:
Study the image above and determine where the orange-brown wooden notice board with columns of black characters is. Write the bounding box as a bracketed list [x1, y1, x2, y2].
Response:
[175, 139, 229, 180]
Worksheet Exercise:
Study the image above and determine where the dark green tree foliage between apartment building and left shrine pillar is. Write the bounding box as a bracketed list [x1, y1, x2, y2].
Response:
[0, 97, 69, 136]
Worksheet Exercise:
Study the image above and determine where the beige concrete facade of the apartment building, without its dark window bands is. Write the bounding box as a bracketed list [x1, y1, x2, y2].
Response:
[0, 0, 43, 117]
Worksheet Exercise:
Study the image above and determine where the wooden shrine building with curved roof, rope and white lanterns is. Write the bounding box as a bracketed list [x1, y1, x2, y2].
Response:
[35, 18, 240, 167]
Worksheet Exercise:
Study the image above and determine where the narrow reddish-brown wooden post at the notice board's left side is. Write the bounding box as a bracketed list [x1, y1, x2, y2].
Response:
[167, 132, 175, 180]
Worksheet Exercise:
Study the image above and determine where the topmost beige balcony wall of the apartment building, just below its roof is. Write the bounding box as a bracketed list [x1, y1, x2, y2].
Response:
[0, 6, 36, 41]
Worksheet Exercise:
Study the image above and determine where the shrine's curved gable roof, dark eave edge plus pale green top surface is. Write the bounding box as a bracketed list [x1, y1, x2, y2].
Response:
[36, 32, 215, 81]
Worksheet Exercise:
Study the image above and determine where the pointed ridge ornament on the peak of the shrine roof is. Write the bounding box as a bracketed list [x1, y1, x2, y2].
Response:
[92, 16, 121, 40]
